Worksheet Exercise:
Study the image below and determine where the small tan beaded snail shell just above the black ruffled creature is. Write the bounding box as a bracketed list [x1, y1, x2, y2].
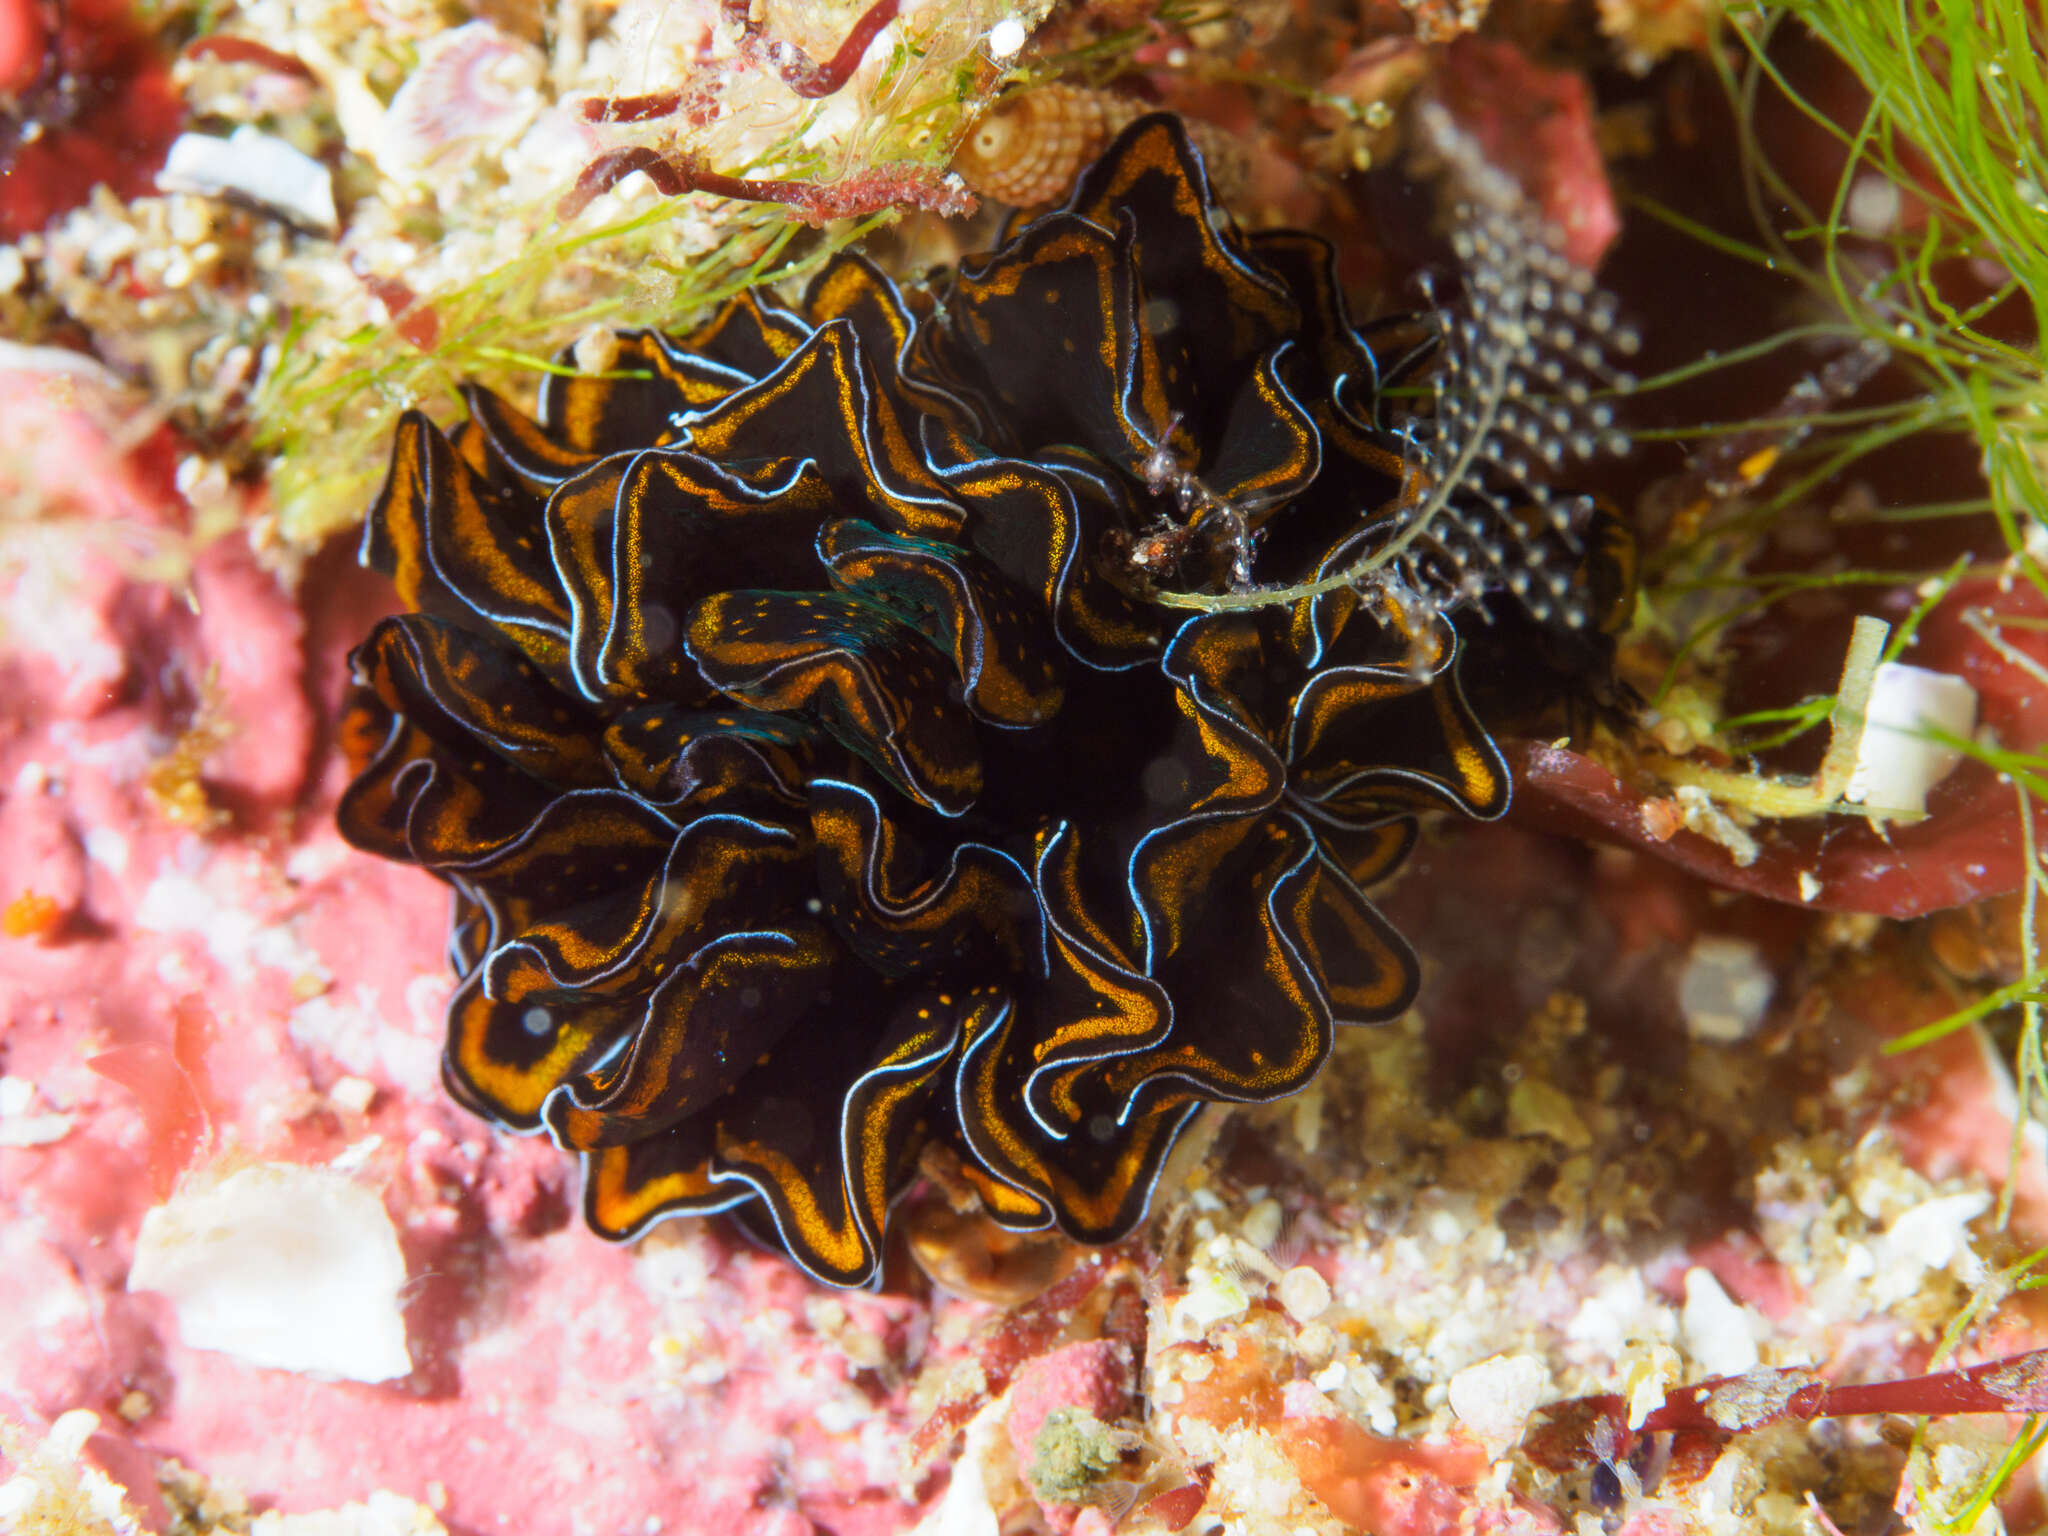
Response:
[952, 84, 1247, 209]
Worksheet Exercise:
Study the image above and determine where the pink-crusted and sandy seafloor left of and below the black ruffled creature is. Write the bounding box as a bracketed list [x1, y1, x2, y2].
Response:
[12, 3, 2048, 1536]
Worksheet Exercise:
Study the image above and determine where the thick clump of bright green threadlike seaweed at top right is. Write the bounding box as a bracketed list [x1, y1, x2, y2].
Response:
[1624, 0, 2048, 843]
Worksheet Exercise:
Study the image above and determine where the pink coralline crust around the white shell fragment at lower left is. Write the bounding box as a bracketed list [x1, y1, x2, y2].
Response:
[0, 373, 942, 1536]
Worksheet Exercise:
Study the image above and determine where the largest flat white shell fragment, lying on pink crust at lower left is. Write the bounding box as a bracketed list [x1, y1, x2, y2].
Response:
[127, 1163, 412, 1382]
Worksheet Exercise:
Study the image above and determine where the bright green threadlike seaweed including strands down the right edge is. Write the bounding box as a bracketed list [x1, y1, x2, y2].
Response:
[1634, 12, 2048, 1530]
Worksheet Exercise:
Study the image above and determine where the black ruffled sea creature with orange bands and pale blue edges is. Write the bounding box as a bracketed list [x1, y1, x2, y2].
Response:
[340, 117, 1540, 1284]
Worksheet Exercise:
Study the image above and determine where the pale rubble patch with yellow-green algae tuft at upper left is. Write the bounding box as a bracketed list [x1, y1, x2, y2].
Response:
[0, 0, 1049, 559]
